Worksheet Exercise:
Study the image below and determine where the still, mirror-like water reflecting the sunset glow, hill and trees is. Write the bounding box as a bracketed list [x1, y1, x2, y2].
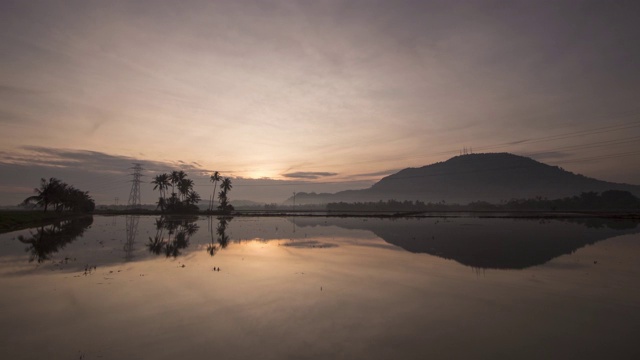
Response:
[0, 216, 640, 359]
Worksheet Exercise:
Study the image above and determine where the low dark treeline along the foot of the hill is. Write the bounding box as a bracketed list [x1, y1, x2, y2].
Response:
[327, 190, 640, 211]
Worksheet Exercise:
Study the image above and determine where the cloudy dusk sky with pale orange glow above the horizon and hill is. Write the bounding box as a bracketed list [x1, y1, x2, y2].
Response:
[0, 0, 640, 205]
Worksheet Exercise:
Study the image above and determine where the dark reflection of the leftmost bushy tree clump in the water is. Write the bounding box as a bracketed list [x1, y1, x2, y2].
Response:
[18, 215, 93, 263]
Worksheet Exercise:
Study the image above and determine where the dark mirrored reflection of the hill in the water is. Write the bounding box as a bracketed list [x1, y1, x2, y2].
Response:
[293, 218, 638, 269]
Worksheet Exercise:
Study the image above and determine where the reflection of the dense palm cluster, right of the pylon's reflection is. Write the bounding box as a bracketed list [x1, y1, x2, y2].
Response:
[147, 216, 199, 257]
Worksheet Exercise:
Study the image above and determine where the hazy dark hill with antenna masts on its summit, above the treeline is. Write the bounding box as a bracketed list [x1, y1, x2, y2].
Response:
[287, 153, 640, 204]
